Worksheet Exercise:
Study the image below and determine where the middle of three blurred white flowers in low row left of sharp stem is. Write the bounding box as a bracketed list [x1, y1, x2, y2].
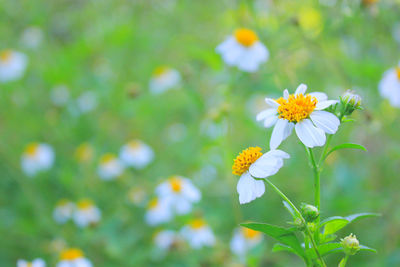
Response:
[181, 219, 215, 249]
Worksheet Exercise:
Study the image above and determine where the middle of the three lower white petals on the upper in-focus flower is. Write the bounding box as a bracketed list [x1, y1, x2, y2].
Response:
[295, 119, 326, 148]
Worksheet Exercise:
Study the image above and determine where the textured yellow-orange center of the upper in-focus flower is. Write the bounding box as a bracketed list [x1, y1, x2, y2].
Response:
[276, 94, 318, 122]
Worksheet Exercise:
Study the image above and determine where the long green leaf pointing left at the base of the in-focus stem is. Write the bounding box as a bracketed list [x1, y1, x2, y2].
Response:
[240, 223, 306, 259]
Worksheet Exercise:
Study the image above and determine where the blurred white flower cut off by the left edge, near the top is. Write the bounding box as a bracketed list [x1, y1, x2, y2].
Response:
[0, 50, 28, 83]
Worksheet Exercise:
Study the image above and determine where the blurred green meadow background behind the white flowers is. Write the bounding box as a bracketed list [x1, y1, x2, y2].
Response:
[0, 0, 400, 267]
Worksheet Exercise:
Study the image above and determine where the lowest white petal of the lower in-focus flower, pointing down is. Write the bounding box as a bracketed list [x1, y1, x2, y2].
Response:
[236, 172, 265, 204]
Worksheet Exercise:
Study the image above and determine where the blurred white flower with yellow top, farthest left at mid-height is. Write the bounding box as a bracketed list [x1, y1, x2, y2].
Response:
[21, 143, 54, 176]
